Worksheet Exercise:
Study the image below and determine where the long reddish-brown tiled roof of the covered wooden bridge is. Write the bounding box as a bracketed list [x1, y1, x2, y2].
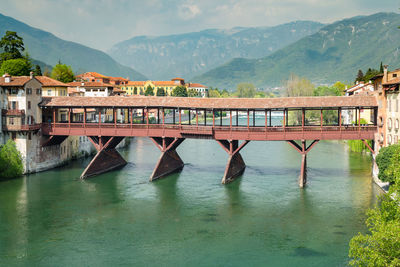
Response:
[40, 96, 378, 109]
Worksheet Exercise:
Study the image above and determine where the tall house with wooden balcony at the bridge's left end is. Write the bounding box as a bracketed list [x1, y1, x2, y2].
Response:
[0, 74, 65, 173]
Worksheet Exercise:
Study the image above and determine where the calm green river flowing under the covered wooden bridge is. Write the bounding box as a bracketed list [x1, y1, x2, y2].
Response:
[0, 118, 380, 266]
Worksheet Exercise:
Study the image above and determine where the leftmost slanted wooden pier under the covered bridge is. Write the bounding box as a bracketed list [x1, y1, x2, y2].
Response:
[81, 136, 126, 179]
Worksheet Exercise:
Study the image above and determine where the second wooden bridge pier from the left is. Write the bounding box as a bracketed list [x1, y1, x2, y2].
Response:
[150, 137, 185, 181]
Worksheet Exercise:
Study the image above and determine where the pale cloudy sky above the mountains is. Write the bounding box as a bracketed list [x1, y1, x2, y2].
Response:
[0, 0, 400, 51]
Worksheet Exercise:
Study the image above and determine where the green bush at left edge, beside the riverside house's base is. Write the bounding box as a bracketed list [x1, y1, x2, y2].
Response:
[0, 139, 24, 179]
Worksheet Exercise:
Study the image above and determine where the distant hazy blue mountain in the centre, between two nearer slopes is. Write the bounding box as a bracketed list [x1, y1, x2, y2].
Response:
[108, 21, 322, 79]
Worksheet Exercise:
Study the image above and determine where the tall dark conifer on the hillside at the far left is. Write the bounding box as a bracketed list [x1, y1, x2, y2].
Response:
[0, 31, 25, 62]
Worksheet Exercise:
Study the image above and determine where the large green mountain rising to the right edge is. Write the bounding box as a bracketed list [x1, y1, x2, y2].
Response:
[193, 13, 400, 89]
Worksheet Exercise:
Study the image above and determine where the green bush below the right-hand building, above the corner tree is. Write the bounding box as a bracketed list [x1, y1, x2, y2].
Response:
[376, 145, 400, 182]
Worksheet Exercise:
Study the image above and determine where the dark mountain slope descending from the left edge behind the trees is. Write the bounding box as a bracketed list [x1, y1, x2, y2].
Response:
[0, 14, 146, 80]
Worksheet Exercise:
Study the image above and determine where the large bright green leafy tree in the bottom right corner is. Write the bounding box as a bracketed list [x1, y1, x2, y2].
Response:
[349, 178, 400, 266]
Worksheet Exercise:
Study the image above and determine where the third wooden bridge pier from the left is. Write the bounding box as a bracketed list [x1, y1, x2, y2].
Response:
[217, 140, 250, 184]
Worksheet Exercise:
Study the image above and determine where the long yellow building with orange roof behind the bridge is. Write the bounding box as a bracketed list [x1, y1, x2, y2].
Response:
[121, 78, 186, 96]
